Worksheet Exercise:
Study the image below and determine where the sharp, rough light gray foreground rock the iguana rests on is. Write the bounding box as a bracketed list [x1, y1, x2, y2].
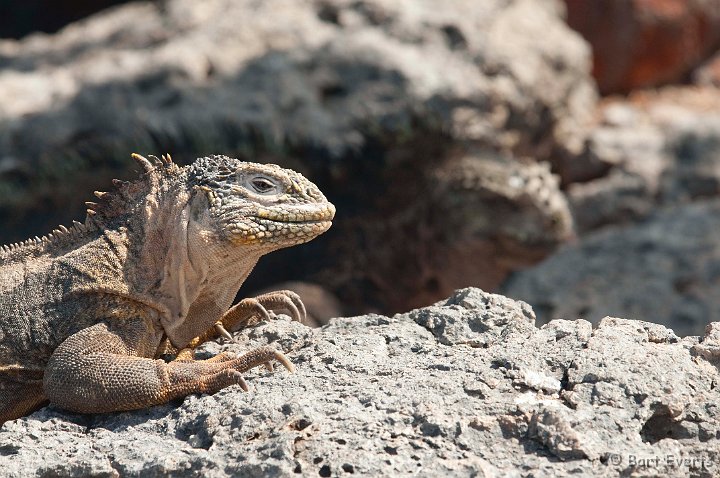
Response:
[0, 289, 720, 477]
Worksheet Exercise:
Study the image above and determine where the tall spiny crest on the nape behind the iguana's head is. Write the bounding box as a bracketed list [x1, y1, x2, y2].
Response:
[85, 153, 181, 218]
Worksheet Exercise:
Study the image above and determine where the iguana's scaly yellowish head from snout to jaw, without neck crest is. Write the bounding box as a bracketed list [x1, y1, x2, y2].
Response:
[188, 156, 335, 250]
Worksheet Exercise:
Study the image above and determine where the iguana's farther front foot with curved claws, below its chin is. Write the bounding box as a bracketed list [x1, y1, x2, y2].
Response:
[215, 290, 307, 334]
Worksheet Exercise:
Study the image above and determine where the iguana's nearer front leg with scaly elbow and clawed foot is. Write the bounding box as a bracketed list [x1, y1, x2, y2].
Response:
[43, 318, 292, 413]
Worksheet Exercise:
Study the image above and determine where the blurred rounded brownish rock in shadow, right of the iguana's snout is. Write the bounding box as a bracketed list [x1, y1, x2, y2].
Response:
[334, 150, 574, 311]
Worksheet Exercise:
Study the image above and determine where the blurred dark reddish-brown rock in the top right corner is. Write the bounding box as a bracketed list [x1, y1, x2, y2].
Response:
[565, 0, 720, 94]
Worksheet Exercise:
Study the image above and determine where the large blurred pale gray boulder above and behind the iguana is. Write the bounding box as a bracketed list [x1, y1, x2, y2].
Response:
[0, 0, 595, 227]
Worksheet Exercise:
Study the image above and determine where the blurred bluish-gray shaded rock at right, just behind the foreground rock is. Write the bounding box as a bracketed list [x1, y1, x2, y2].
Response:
[502, 199, 720, 335]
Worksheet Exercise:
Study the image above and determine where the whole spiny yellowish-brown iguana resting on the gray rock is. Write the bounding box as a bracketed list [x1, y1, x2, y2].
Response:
[0, 154, 335, 424]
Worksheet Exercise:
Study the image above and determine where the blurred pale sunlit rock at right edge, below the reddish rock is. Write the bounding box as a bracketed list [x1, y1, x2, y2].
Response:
[564, 87, 720, 234]
